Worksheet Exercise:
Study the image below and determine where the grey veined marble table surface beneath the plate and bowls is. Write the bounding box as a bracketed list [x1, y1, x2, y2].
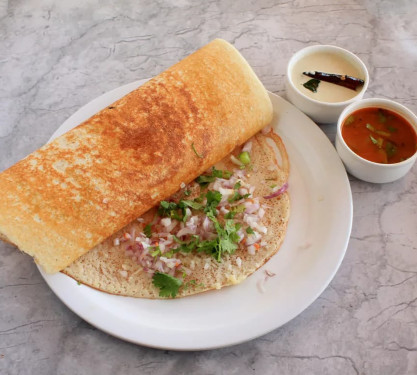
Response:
[0, 0, 417, 375]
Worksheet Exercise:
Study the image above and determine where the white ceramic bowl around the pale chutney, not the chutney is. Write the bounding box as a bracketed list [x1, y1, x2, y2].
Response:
[286, 45, 369, 124]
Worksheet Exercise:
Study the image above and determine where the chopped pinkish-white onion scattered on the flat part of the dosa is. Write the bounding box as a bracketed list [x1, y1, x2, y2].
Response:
[119, 167, 276, 276]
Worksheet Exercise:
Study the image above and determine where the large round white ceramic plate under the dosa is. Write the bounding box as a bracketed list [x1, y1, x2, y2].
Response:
[38, 81, 352, 350]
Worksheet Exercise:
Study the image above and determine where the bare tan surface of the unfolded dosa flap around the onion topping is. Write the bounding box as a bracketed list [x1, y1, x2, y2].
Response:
[63, 133, 290, 298]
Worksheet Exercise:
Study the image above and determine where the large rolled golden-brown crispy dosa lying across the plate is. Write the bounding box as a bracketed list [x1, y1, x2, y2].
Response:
[0, 40, 272, 273]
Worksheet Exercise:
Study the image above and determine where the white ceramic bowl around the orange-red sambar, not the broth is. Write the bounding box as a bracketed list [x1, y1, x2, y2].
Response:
[336, 99, 417, 183]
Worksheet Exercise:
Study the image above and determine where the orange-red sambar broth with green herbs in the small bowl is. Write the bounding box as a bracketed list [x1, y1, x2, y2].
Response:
[342, 108, 417, 164]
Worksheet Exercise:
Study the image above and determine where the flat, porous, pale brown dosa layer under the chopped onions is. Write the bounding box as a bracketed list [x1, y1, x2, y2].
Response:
[62, 132, 290, 299]
